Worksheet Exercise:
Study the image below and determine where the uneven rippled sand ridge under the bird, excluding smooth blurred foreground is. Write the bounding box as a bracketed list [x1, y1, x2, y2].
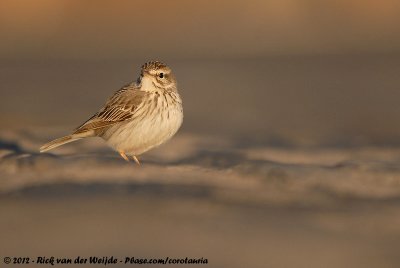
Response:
[0, 130, 400, 206]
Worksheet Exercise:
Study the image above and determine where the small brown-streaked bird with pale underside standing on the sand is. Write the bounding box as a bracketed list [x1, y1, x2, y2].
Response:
[39, 61, 183, 165]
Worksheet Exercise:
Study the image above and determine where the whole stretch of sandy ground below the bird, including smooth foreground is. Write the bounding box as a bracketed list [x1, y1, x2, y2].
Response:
[0, 129, 400, 267]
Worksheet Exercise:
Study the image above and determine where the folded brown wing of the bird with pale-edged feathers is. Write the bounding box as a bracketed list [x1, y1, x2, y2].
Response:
[74, 84, 147, 134]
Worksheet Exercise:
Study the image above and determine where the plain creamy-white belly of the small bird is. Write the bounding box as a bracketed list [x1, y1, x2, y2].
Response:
[102, 105, 183, 155]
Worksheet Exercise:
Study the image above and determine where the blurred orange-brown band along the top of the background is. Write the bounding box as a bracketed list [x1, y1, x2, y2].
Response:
[0, 0, 400, 58]
